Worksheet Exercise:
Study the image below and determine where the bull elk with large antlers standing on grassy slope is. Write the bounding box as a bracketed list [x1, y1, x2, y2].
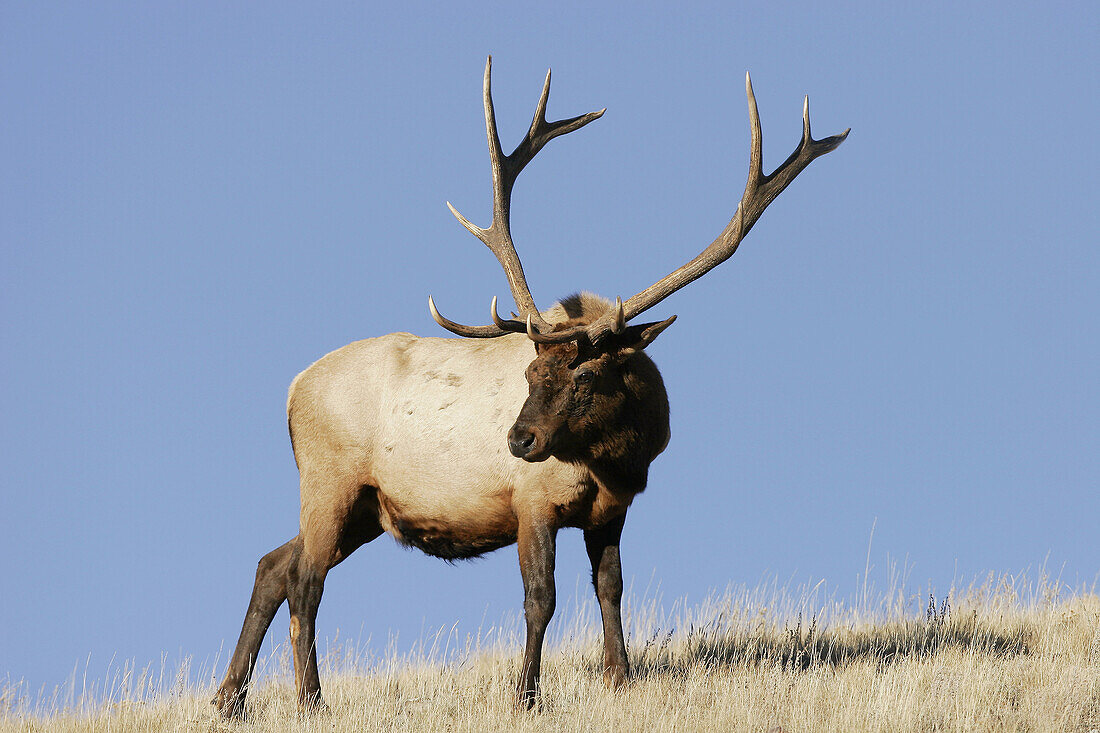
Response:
[213, 57, 848, 716]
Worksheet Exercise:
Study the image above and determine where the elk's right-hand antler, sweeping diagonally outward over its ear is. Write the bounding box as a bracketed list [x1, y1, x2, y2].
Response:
[532, 74, 851, 343]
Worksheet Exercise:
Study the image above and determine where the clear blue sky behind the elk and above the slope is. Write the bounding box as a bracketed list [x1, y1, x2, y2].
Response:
[0, 0, 1100, 688]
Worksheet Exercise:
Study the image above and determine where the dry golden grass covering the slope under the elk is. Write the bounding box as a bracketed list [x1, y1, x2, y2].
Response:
[0, 578, 1100, 733]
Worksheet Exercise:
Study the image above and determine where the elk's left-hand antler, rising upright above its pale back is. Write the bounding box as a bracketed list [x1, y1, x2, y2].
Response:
[428, 56, 606, 338]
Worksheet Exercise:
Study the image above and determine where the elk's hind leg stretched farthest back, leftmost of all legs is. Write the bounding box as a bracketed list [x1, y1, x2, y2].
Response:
[212, 538, 298, 718]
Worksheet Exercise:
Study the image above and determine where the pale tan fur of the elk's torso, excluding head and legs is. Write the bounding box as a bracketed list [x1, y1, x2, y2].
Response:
[287, 314, 634, 561]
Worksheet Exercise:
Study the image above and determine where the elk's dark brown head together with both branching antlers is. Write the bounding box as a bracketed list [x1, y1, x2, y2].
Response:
[428, 56, 849, 463]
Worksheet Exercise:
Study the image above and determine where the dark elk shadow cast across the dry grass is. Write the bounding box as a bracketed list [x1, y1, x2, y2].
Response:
[624, 604, 1033, 678]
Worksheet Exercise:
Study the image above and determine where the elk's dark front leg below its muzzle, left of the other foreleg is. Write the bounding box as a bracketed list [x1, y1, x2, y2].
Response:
[517, 512, 557, 709]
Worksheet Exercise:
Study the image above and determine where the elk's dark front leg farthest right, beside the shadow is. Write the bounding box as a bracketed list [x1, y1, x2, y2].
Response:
[584, 514, 630, 689]
